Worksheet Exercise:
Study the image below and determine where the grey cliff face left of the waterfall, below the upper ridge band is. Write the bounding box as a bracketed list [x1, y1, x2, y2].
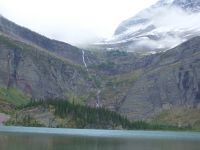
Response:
[0, 35, 92, 101]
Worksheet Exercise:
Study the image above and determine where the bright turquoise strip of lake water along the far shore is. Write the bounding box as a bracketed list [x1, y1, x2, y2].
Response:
[0, 126, 200, 141]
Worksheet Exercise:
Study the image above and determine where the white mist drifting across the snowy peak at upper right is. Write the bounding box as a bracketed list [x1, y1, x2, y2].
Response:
[125, 4, 200, 51]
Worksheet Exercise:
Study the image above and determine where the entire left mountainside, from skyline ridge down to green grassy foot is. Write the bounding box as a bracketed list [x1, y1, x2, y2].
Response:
[0, 17, 101, 105]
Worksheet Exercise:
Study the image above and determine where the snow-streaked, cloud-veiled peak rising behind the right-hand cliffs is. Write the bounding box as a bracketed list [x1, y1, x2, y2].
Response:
[96, 0, 200, 54]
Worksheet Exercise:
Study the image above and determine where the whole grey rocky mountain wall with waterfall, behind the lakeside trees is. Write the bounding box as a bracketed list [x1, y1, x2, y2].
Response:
[0, 15, 200, 129]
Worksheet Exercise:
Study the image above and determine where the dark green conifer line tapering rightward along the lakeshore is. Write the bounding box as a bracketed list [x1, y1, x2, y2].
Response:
[17, 99, 191, 130]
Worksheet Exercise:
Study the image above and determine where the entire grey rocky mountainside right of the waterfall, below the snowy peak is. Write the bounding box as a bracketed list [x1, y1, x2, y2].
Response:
[92, 37, 200, 120]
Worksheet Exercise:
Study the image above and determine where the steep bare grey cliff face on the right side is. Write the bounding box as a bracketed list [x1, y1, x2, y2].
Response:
[120, 37, 200, 119]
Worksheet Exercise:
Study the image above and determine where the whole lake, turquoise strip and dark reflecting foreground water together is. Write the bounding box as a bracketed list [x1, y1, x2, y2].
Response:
[0, 126, 200, 150]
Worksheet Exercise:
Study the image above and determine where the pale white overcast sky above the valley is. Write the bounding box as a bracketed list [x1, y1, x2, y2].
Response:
[0, 0, 157, 45]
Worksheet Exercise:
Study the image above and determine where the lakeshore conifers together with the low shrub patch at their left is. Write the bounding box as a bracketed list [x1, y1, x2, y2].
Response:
[6, 100, 190, 130]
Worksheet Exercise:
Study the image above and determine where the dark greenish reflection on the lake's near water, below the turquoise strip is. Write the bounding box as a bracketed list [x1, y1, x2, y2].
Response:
[0, 127, 200, 150]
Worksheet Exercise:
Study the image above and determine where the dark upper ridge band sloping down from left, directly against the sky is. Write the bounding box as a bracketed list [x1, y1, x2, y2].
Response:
[0, 16, 96, 65]
